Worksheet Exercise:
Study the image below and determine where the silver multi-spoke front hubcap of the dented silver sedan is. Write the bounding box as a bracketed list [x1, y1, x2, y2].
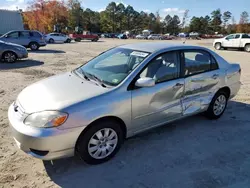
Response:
[88, 128, 118, 159]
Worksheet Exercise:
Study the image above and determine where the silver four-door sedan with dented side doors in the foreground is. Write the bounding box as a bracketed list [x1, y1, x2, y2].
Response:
[8, 42, 241, 164]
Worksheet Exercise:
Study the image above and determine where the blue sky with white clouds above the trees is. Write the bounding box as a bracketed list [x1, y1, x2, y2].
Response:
[0, 0, 250, 21]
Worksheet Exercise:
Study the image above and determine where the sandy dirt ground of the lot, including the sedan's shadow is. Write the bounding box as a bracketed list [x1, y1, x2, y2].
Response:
[0, 39, 250, 188]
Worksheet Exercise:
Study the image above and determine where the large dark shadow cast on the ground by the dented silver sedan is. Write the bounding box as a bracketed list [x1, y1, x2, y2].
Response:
[44, 101, 250, 188]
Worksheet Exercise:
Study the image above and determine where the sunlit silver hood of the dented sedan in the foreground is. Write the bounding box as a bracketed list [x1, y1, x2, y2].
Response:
[17, 72, 108, 114]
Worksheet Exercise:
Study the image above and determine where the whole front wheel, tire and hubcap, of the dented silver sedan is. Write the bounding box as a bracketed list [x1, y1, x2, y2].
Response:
[76, 121, 124, 164]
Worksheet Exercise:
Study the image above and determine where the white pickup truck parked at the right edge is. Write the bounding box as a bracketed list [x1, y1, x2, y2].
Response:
[213, 33, 250, 52]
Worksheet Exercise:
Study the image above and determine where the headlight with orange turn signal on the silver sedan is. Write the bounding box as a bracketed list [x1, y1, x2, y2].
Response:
[24, 111, 68, 128]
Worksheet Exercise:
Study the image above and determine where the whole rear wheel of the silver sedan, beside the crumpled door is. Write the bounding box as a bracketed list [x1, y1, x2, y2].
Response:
[205, 91, 229, 119]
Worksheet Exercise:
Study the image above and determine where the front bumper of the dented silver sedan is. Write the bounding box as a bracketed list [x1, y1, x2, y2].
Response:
[8, 104, 82, 160]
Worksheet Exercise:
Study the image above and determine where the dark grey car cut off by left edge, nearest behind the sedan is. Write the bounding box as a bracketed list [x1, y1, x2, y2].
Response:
[0, 40, 28, 63]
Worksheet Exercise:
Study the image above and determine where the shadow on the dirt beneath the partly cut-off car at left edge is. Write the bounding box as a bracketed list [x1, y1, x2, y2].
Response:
[0, 59, 44, 70]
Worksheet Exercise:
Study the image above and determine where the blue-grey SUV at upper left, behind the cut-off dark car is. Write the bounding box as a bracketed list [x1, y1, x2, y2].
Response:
[0, 30, 46, 50]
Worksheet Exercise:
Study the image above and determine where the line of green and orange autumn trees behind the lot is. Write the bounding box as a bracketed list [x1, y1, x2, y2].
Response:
[22, 0, 250, 34]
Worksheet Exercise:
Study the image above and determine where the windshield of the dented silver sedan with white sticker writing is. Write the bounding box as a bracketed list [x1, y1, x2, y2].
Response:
[75, 48, 149, 87]
